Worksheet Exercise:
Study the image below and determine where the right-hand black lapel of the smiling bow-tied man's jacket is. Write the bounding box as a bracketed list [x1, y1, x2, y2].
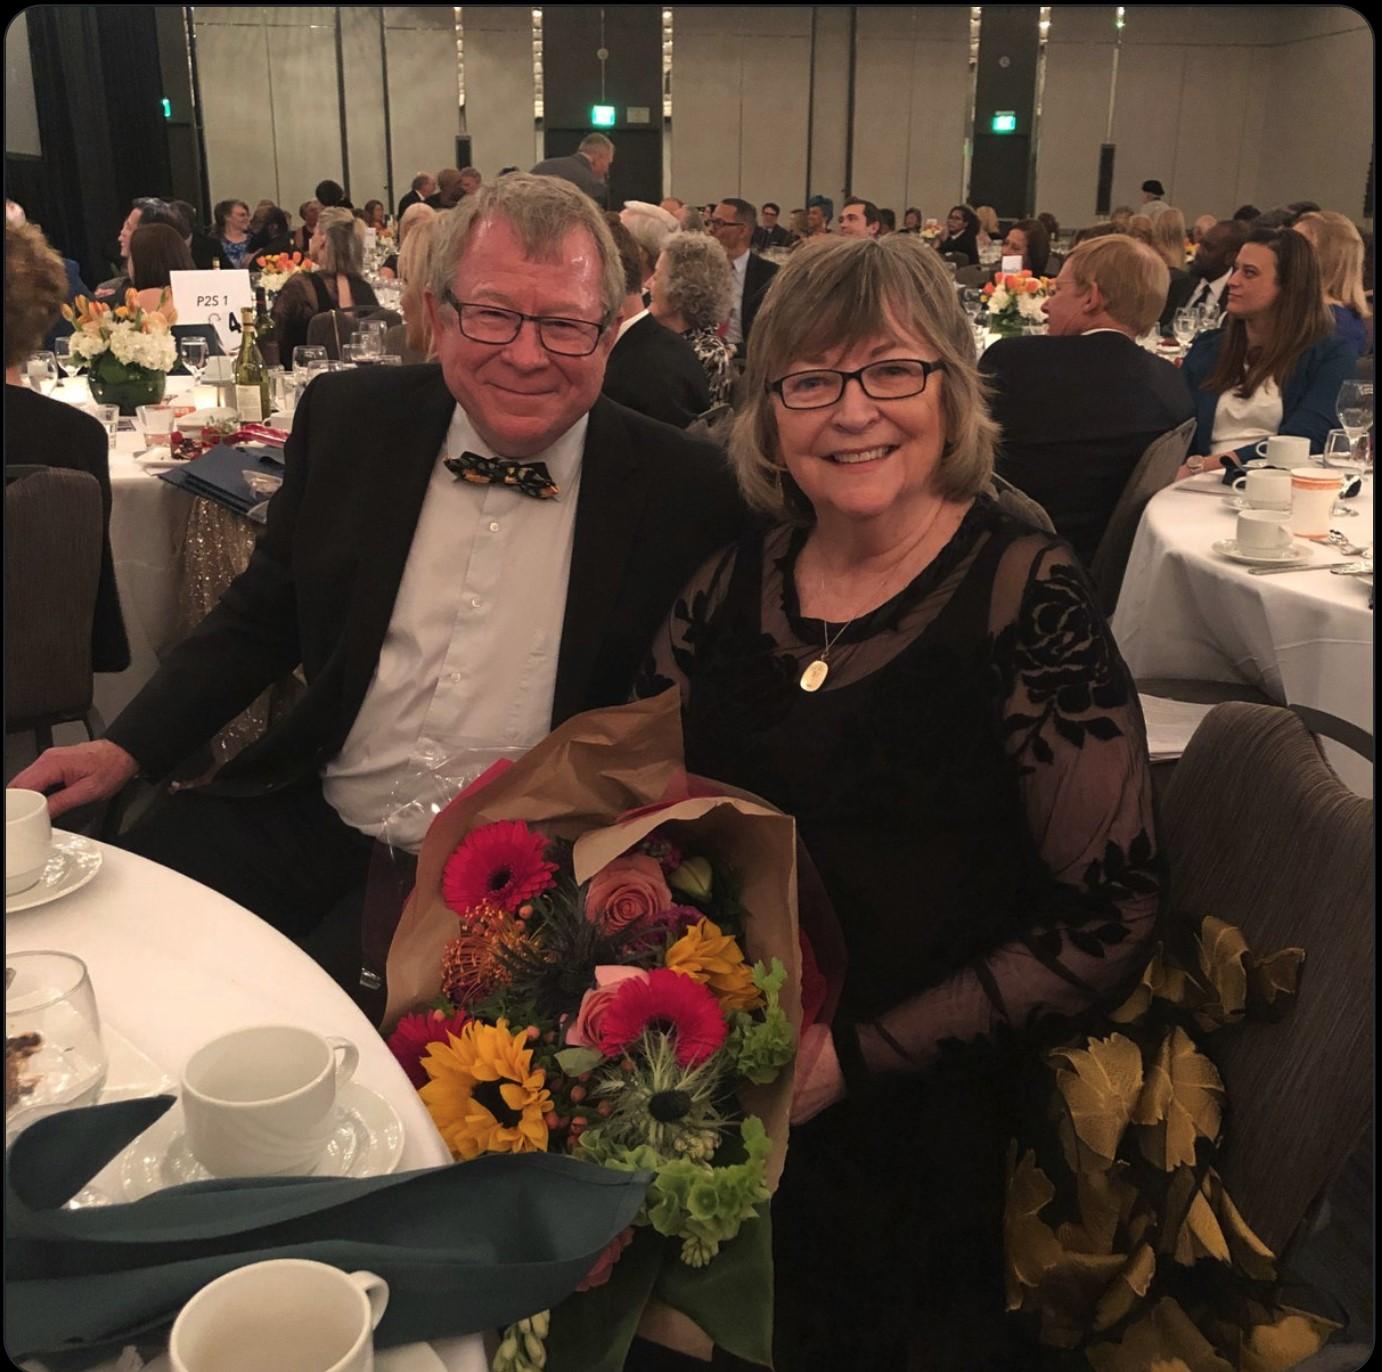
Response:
[551, 397, 648, 724]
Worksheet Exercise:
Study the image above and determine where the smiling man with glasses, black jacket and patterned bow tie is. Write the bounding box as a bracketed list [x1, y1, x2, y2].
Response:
[14, 174, 744, 966]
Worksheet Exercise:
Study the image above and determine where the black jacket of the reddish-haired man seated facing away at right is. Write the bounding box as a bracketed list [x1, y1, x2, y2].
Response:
[978, 333, 1193, 565]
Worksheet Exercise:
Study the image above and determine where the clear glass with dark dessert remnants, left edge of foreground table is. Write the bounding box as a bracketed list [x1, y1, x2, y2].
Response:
[4, 952, 106, 1140]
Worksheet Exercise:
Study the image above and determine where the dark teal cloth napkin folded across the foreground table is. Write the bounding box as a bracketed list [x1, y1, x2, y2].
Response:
[4, 1096, 651, 1365]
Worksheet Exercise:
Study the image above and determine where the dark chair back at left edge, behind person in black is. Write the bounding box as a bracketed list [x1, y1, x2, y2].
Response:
[4, 466, 102, 752]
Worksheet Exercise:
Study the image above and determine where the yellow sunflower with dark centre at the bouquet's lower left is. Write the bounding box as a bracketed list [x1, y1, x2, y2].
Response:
[420, 1020, 551, 1162]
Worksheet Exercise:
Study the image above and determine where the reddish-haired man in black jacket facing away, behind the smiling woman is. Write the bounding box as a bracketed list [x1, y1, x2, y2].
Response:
[978, 234, 1194, 565]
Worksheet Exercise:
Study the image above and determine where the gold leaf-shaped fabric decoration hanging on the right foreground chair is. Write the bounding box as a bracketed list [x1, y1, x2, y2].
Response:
[1003, 917, 1339, 1372]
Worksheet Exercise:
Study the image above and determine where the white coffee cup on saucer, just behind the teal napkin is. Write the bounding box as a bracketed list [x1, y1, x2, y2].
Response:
[182, 1024, 359, 1177]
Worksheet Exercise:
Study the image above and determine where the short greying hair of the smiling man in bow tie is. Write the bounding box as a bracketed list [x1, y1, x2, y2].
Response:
[427, 171, 625, 323]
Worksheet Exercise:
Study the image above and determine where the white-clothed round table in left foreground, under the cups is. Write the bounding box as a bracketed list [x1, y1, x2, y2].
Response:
[6, 844, 489, 1372]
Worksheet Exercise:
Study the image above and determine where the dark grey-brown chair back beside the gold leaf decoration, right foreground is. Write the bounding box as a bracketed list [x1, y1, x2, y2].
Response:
[1161, 702, 1374, 1264]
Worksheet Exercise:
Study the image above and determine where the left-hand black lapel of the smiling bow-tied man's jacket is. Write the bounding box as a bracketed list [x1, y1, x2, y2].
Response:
[337, 368, 456, 742]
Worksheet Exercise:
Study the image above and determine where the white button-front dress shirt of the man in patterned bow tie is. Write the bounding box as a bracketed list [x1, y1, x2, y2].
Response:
[322, 405, 589, 847]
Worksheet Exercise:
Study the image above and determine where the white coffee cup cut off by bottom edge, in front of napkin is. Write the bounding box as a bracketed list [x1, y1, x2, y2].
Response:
[169, 1257, 388, 1372]
